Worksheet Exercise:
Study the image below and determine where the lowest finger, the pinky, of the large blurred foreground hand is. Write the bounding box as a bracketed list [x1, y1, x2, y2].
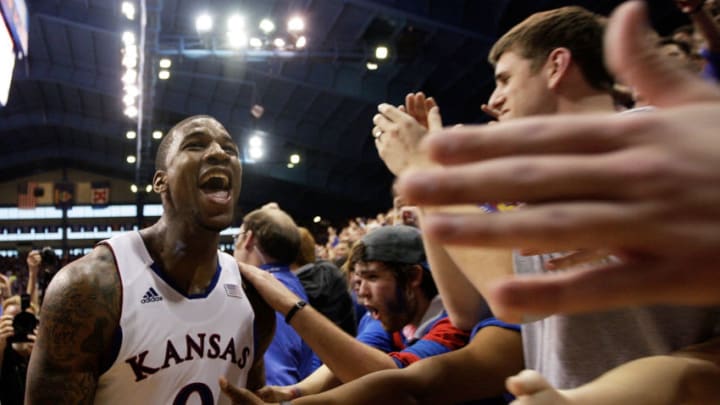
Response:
[488, 257, 720, 314]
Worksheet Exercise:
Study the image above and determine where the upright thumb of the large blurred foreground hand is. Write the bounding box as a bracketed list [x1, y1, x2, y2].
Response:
[605, 1, 720, 107]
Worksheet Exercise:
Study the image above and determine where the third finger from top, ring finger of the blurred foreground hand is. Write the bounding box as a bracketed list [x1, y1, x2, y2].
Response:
[416, 202, 668, 251]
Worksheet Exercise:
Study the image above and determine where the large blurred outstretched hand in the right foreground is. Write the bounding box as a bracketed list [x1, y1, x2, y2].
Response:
[397, 1, 720, 314]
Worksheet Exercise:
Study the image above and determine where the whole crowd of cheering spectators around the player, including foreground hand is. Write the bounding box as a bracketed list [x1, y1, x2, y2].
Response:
[7, 0, 720, 404]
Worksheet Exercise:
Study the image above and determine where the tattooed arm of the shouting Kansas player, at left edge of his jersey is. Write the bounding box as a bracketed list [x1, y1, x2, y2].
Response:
[25, 246, 121, 405]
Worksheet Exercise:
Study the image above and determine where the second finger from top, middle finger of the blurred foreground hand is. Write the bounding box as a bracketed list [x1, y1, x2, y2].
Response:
[396, 154, 640, 205]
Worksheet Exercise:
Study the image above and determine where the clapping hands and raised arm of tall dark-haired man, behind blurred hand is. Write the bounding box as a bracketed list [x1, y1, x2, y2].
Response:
[373, 93, 512, 330]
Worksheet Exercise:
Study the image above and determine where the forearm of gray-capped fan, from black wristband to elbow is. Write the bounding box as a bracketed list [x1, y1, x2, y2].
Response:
[290, 306, 397, 382]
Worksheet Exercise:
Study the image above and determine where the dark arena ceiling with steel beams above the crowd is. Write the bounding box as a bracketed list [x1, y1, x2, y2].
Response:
[0, 0, 687, 222]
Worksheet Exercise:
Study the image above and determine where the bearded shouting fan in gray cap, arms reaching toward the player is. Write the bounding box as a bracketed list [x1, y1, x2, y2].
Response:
[223, 225, 469, 402]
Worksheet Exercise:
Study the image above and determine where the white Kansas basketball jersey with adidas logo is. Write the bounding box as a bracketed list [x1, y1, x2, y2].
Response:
[95, 232, 255, 405]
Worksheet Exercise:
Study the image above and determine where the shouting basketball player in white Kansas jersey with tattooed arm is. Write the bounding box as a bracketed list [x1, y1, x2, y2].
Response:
[26, 116, 274, 404]
